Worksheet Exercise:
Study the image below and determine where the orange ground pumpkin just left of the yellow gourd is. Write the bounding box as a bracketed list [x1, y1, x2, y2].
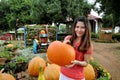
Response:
[28, 57, 46, 76]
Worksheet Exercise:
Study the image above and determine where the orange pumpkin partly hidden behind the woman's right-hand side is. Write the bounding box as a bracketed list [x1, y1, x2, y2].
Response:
[84, 64, 95, 80]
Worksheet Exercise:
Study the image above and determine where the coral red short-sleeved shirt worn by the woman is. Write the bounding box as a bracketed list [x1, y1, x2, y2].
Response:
[61, 36, 93, 80]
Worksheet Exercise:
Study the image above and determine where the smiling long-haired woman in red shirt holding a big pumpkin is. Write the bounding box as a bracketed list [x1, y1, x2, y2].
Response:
[59, 17, 93, 80]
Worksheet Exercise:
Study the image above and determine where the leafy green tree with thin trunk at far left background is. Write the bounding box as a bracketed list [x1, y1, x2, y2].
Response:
[6, 0, 30, 38]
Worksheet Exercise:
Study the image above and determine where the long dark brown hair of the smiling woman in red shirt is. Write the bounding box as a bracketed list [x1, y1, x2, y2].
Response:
[70, 16, 91, 53]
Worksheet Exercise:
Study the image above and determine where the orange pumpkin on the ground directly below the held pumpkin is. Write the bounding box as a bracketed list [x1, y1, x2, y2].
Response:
[44, 64, 60, 80]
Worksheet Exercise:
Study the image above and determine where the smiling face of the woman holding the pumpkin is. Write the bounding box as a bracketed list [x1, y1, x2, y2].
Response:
[75, 21, 85, 38]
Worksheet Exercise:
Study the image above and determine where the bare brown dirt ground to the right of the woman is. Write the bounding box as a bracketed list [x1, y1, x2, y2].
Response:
[93, 42, 120, 80]
